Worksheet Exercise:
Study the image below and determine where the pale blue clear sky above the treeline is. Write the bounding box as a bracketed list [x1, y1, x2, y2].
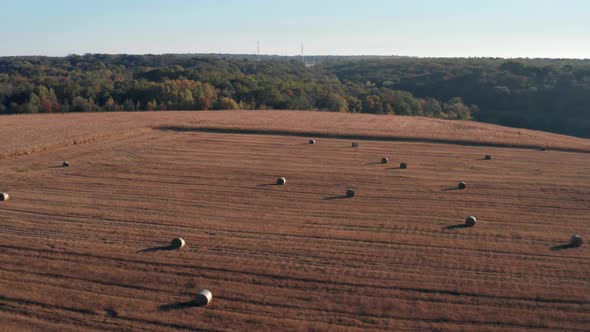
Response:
[0, 0, 590, 58]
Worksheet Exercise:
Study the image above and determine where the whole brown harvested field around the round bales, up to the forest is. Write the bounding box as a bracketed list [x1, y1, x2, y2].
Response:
[0, 112, 590, 331]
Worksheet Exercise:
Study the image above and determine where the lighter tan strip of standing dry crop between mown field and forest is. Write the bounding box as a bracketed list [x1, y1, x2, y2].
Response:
[0, 111, 590, 159]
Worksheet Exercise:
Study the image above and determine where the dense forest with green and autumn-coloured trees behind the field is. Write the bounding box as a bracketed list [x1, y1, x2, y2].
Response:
[0, 54, 590, 137]
